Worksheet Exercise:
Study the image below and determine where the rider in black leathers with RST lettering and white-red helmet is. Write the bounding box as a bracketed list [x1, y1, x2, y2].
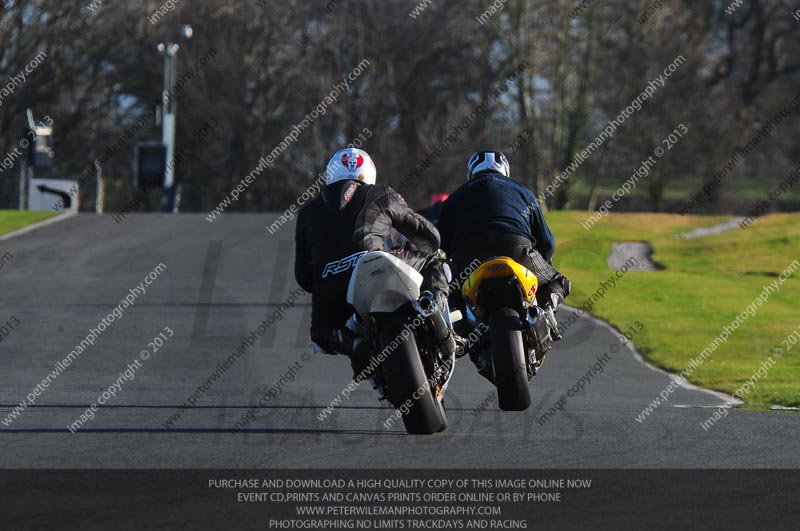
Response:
[295, 148, 450, 379]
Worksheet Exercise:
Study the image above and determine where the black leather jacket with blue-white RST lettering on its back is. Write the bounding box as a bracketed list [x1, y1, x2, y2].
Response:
[294, 180, 440, 330]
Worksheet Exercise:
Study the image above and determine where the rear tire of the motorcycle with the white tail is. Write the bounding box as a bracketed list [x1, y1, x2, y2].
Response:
[380, 321, 447, 435]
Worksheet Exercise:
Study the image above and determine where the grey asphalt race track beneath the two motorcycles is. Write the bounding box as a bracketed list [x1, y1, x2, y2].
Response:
[0, 214, 800, 468]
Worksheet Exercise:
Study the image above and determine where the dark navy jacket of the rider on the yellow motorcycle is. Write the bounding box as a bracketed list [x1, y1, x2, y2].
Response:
[437, 172, 555, 262]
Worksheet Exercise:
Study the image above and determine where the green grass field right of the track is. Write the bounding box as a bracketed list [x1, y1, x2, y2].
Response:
[547, 211, 800, 406]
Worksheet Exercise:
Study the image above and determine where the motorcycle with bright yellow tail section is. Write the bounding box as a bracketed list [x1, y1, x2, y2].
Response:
[461, 256, 555, 411]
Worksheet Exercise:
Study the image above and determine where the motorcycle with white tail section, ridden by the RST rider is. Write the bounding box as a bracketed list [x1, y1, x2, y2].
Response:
[347, 251, 460, 434]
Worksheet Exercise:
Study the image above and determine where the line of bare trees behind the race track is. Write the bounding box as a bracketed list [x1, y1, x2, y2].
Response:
[0, 0, 800, 213]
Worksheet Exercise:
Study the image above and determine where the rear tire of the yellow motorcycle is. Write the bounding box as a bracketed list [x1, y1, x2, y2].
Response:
[489, 308, 531, 411]
